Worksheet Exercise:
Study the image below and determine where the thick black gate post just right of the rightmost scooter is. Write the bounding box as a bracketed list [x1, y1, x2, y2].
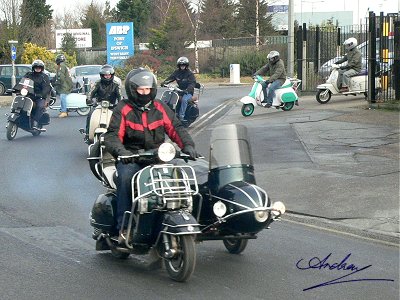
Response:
[368, 11, 376, 103]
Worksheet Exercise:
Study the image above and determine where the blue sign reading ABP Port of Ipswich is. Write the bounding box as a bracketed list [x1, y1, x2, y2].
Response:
[106, 22, 135, 66]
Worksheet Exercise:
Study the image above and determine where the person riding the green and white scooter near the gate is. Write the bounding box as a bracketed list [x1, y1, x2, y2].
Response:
[253, 51, 286, 108]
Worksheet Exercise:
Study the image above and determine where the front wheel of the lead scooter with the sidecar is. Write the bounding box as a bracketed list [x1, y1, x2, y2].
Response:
[164, 235, 196, 282]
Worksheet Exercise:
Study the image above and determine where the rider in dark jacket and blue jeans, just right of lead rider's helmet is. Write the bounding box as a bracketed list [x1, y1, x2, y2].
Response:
[161, 56, 196, 123]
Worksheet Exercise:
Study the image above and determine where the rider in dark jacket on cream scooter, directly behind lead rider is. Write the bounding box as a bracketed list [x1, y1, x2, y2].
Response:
[85, 65, 122, 141]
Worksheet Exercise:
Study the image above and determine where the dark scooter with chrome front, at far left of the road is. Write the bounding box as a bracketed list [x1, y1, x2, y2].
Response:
[6, 77, 50, 141]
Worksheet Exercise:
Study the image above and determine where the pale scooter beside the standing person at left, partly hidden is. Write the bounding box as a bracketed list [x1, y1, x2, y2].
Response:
[49, 78, 90, 116]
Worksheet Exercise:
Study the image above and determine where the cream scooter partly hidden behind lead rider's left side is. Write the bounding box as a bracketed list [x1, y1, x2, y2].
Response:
[79, 100, 112, 145]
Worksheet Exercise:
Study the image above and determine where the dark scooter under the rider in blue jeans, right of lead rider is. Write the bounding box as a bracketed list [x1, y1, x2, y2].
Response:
[161, 82, 204, 127]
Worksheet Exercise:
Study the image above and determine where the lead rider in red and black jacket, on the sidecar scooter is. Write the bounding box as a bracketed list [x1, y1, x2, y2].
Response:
[104, 68, 198, 242]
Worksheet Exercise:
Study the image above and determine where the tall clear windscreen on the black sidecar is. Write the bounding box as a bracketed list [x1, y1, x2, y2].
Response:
[210, 124, 253, 170]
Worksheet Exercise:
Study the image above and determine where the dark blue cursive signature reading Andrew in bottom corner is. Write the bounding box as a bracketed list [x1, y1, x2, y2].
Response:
[296, 253, 394, 291]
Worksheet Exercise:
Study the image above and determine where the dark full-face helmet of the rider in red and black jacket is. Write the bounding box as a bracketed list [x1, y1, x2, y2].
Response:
[125, 68, 157, 105]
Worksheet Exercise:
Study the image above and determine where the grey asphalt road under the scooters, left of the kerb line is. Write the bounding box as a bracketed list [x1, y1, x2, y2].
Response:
[0, 87, 399, 299]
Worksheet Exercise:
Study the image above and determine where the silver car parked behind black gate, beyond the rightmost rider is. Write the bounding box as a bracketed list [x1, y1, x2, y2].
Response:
[318, 36, 394, 80]
